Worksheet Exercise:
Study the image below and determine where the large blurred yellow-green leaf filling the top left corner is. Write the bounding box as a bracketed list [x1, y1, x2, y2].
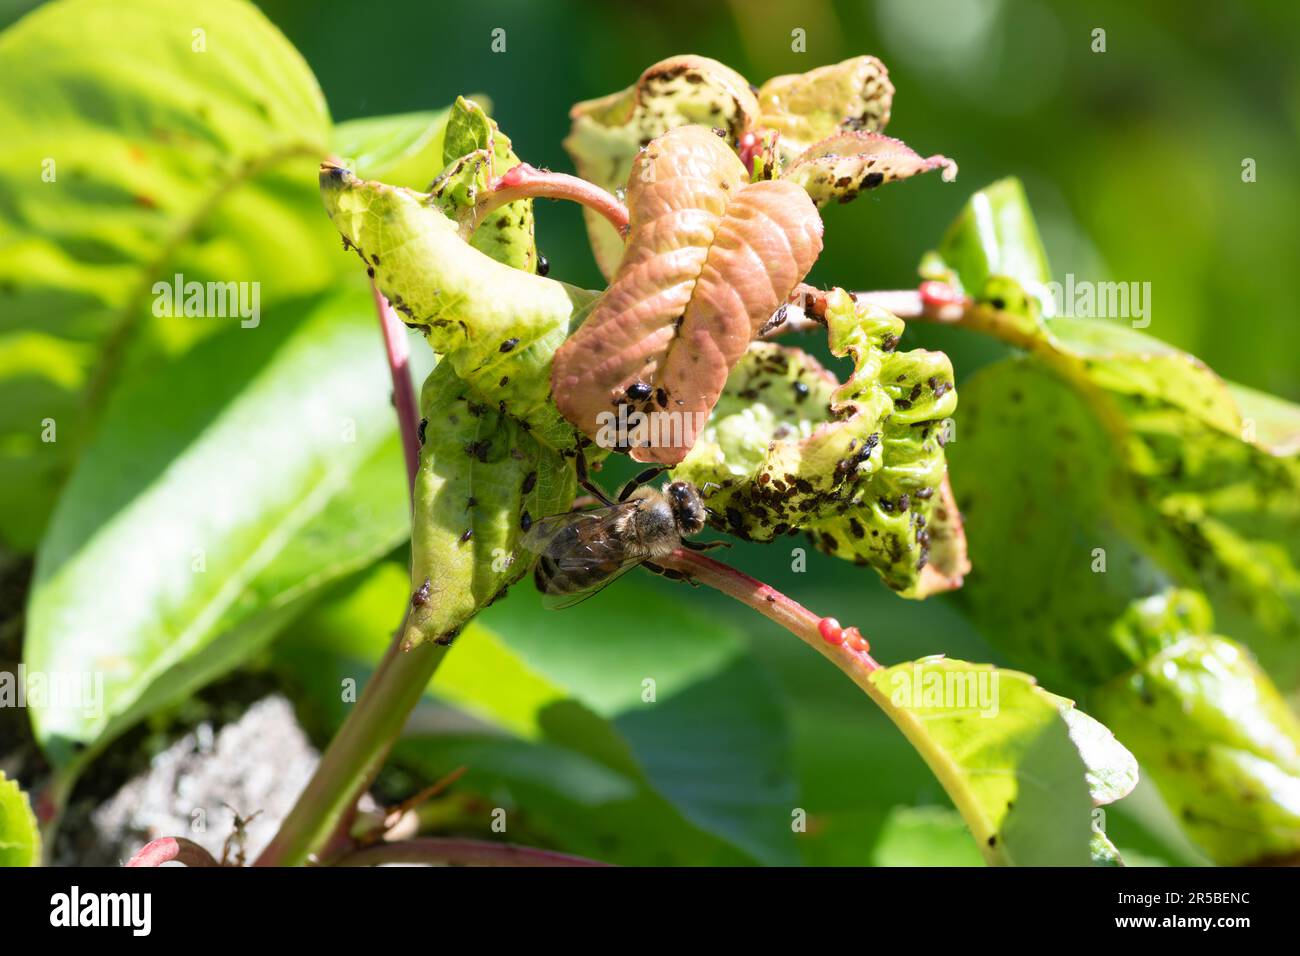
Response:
[0, 0, 339, 549]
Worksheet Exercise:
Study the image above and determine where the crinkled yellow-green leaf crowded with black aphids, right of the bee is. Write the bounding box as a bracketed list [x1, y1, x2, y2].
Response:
[673, 289, 969, 597]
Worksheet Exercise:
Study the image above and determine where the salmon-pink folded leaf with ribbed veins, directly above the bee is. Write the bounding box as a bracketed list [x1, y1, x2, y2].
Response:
[551, 126, 822, 464]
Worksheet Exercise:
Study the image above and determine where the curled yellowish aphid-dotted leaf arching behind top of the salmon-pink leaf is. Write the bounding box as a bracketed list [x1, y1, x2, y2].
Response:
[564, 55, 758, 278]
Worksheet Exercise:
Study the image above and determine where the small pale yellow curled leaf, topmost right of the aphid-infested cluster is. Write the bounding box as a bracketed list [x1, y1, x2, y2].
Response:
[758, 56, 894, 163]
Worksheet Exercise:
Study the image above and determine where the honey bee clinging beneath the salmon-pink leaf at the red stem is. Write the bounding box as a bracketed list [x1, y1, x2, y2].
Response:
[523, 454, 727, 609]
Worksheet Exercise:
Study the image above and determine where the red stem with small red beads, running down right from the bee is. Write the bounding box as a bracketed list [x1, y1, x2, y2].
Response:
[655, 548, 880, 684]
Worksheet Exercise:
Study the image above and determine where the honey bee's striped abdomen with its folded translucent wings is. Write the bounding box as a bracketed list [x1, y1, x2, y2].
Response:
[523, 502, 647, 610]
